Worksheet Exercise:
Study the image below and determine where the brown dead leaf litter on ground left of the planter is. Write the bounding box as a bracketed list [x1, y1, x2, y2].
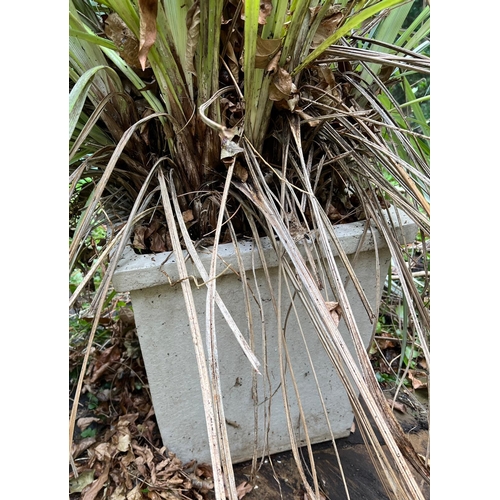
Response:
[69, 298, 232, 500]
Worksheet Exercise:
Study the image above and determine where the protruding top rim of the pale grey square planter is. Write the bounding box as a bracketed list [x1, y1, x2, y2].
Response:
[113, 207, 415, 292]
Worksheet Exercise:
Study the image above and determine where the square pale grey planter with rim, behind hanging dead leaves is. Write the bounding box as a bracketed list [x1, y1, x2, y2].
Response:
[113, 208, 417, 463]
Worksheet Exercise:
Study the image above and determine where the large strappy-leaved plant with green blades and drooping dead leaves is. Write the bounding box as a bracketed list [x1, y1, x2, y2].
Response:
[69, 0, 430, 499]
